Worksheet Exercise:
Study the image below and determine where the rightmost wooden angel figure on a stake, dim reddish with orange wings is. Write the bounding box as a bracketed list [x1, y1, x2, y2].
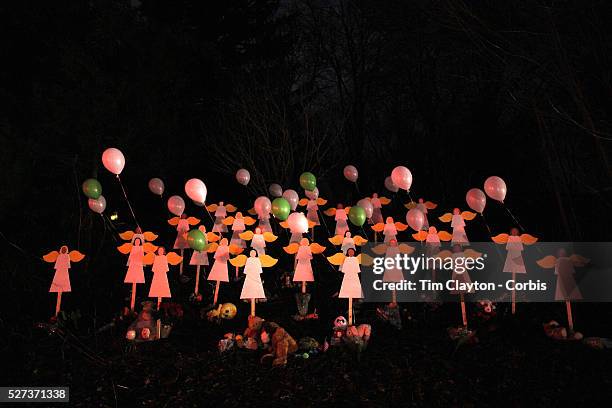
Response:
[536, 248, 589, 332]
